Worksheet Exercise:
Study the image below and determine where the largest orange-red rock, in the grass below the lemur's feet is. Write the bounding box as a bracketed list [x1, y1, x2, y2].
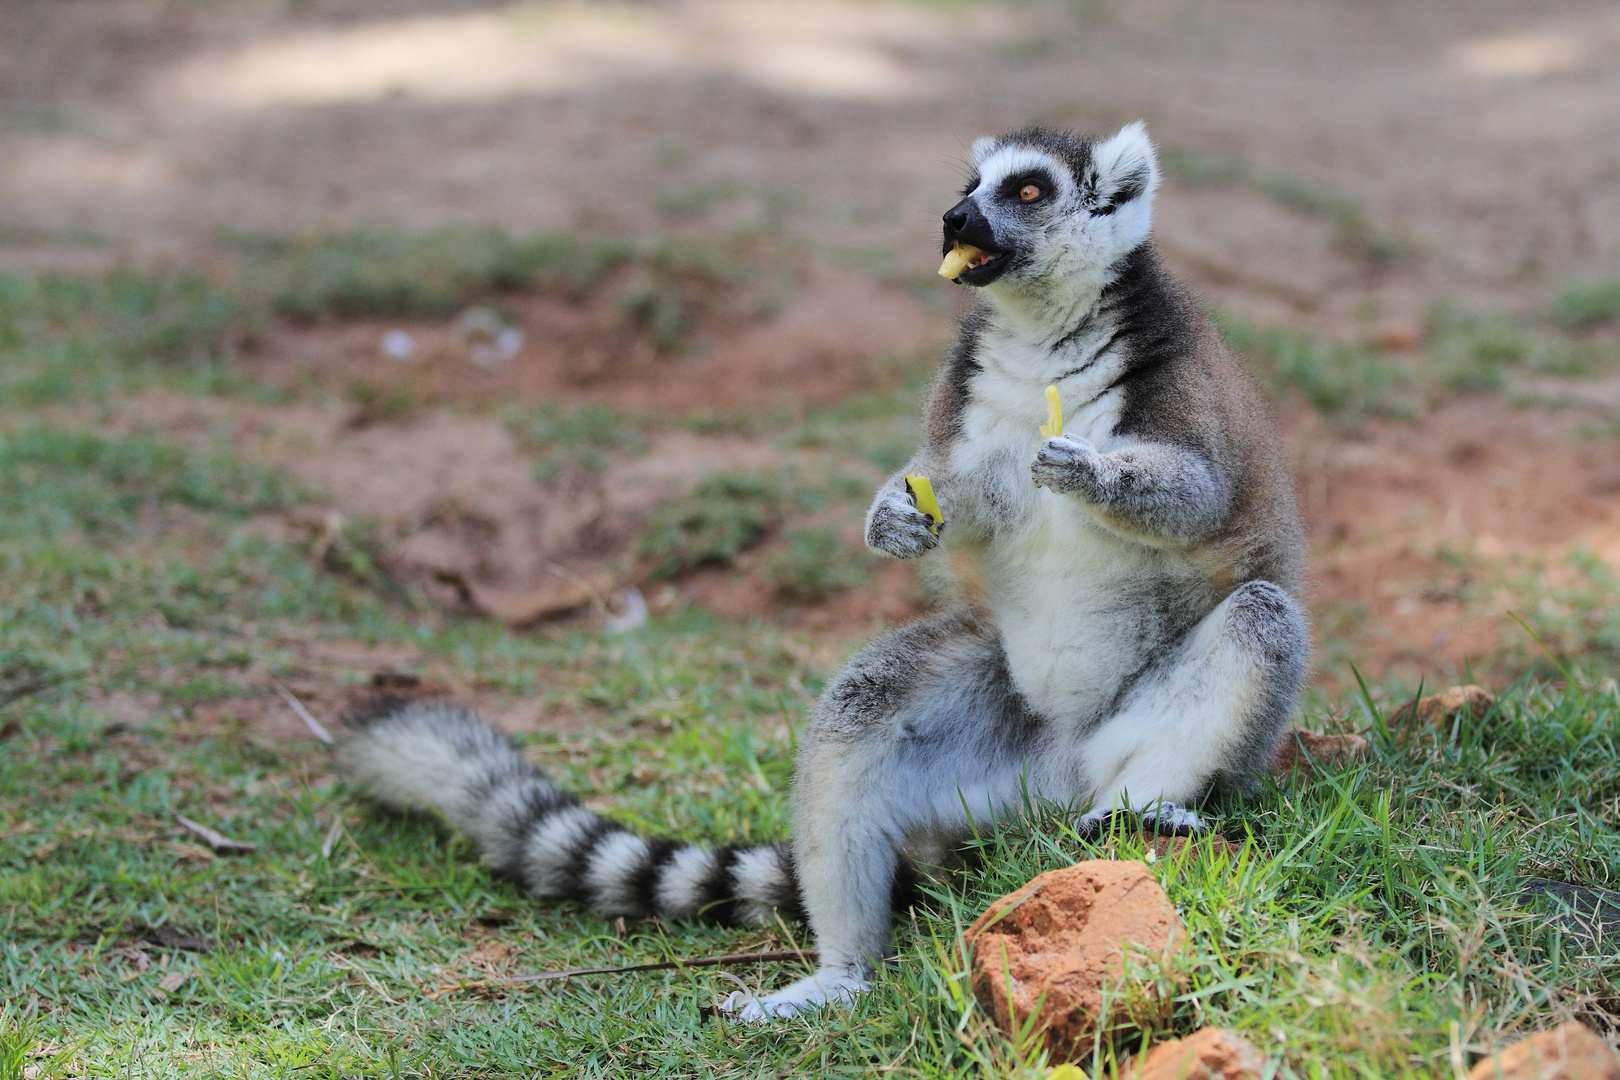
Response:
[962, 858, 1186, 1061]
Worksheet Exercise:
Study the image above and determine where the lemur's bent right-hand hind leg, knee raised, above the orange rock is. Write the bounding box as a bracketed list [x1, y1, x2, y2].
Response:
[1081, 581, 1311, 832]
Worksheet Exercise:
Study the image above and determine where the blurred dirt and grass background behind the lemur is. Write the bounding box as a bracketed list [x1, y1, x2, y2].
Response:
[0, 0, 1620, 709]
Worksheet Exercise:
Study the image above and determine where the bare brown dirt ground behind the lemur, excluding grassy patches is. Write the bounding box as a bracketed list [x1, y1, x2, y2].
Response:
[0, 0, 1620, 693]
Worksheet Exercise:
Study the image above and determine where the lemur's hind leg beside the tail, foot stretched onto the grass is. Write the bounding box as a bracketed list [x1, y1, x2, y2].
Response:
[726, 612, 1049, 1020]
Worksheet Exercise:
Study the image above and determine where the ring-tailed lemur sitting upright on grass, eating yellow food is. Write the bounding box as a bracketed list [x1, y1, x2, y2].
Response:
[342, 125, 1309, 1018]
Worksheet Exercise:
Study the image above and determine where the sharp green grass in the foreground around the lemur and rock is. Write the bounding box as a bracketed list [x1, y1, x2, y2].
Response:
[0, 619, 1620, 1077]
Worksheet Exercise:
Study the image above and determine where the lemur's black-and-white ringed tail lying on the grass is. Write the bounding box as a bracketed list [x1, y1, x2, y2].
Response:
[339, 698, 804, 925]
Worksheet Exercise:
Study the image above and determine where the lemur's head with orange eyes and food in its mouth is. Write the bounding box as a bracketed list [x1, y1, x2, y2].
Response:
[944, 121, 1158, 293]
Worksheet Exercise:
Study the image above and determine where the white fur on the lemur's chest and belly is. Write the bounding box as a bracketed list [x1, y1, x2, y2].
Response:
[946, 320, 1210, 725]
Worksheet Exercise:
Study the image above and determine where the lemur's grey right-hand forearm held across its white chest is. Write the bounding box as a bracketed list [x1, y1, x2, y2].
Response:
[1029, 436, 1231, 544]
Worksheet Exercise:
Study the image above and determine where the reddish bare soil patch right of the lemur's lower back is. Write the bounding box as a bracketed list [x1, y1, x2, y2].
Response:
[1293, 395, 1620, 680]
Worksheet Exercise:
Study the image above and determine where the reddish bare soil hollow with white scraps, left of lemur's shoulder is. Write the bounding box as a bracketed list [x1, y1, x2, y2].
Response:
[246, 264, 949, 415]
